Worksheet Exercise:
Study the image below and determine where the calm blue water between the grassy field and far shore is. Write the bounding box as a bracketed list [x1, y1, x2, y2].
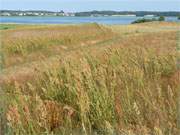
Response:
[0, 16, 180, 24]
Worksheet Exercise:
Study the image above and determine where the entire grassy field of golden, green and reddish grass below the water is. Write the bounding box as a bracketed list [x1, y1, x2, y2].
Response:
[0, 22, 180, 135]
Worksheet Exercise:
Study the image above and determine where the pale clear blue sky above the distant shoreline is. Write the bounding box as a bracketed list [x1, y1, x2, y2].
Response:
[0, 0, 180, 11]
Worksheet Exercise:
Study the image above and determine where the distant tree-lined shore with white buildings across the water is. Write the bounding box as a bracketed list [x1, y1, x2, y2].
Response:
[0, 10, 180, 17]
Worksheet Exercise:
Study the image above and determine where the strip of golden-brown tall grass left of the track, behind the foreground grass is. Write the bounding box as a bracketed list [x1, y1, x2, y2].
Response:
[2, 23, 114, 67]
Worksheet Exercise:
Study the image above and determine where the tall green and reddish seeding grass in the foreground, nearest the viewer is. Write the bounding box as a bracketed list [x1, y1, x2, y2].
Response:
[3, 43, 179, 135]
